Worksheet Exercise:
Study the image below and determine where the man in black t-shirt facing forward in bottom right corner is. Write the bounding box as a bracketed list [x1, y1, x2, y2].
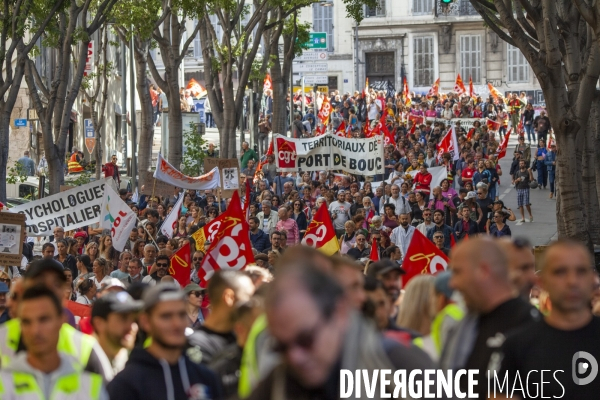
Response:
[489, 241, 600, 399]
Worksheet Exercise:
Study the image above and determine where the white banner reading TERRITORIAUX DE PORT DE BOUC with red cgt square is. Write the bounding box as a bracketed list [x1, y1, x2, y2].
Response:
[275, 133, 384, 176]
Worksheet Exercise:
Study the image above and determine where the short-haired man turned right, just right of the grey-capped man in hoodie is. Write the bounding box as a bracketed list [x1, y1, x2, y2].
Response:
[188, 270, 254, 364]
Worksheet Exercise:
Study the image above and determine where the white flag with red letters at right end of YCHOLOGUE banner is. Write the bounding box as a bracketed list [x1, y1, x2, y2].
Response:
[100, 185, 137, 251]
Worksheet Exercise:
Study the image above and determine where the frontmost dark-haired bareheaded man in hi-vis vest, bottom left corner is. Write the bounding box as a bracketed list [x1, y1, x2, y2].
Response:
[0, 284, 108, 400]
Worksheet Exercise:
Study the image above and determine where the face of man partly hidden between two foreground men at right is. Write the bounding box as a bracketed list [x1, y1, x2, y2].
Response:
[498, 238, 537, 301]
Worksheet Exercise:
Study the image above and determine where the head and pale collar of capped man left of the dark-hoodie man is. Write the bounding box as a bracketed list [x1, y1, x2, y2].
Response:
[91, 292, 143, 379]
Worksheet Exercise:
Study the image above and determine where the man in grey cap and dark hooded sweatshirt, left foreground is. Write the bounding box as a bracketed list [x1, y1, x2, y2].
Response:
[107, 283, 221, 400]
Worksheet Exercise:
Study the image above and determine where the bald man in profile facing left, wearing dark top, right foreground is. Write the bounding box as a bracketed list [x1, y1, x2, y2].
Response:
[440, 238, 539, 399]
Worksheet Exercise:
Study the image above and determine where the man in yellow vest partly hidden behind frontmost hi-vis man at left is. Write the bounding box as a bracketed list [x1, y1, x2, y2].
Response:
[0, 259, 111, 378]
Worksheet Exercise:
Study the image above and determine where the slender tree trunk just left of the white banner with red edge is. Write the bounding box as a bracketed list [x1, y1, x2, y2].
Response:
[134, 38, 154, 187]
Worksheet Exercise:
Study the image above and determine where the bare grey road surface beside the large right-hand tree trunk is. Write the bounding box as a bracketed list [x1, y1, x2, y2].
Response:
[500, 135, 557, 246]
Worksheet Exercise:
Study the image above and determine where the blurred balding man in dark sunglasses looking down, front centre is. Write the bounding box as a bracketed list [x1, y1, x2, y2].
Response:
[249, 257, 433, 400]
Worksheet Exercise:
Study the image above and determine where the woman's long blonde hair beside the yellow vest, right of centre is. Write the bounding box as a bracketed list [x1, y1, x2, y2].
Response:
[396, 275, 435, 336]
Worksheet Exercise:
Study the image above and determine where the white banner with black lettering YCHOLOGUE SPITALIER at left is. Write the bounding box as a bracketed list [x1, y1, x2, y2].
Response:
[10, 179, 112, 236]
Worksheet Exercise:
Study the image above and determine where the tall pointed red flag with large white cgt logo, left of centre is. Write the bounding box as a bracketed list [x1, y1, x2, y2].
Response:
[198, 191, 254, 287]
